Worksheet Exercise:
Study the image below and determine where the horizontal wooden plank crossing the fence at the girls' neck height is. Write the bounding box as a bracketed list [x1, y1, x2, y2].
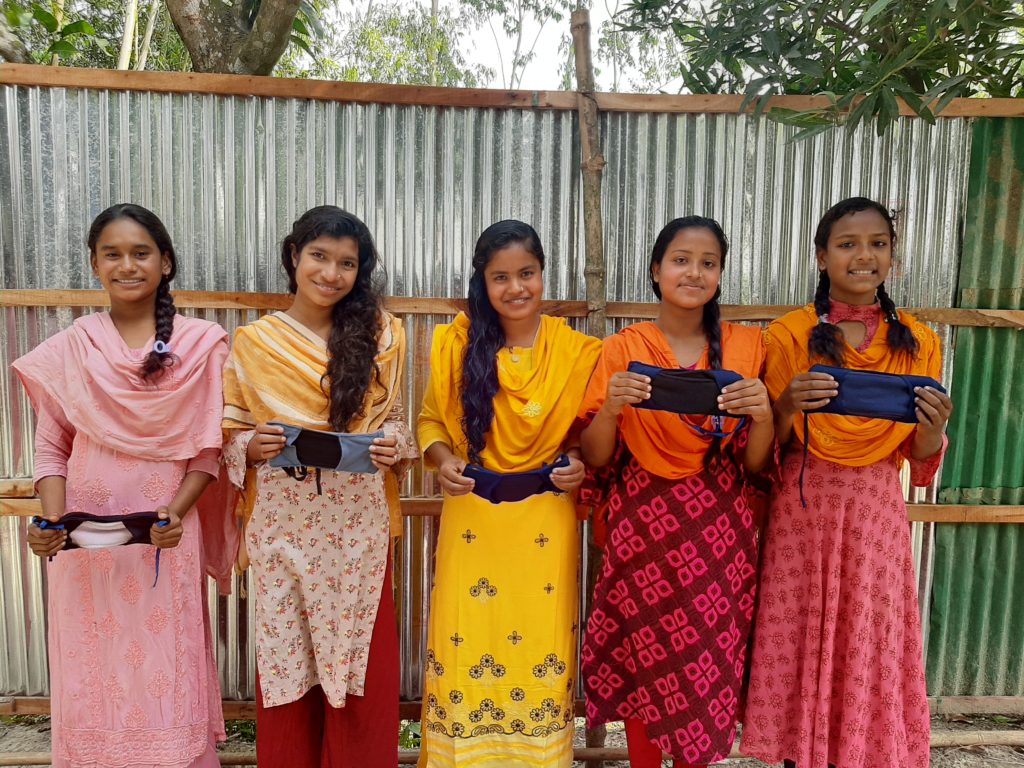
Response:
[0, 289, 1024, 330]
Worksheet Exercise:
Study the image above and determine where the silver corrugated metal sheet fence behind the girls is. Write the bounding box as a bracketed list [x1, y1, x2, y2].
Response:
[0, 81, 991, 698]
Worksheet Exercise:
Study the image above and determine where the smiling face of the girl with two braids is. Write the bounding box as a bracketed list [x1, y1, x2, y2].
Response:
[816, 209, 893, 304]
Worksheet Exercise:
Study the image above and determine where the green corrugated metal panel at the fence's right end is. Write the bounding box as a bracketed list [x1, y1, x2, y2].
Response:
[928, 119, 1024, 695]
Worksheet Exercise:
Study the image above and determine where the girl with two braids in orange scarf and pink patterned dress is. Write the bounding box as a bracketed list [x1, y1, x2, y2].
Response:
[742, 198, 952, 768]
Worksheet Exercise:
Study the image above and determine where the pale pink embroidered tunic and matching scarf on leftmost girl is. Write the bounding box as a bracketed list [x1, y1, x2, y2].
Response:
[14, 312, 227, 768]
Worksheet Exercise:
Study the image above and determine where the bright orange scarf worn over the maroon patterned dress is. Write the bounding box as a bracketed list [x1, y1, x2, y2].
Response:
[580, 322, 765, 480]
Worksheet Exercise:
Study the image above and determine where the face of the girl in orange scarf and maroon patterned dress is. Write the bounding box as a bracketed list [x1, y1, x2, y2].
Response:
[650, 226, 722, 309]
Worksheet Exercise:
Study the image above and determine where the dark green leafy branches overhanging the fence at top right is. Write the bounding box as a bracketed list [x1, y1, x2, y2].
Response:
[620, 0, 1024, 134]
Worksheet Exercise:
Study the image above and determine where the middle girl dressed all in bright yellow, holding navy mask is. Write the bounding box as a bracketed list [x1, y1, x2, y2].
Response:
[419, 221, 600, 768]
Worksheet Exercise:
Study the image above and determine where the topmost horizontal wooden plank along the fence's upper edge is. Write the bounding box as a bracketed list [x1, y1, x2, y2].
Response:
[0, 63, 1024, 118]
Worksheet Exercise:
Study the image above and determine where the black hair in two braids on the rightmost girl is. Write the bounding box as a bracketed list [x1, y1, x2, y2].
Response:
[807, 198, 919, 366]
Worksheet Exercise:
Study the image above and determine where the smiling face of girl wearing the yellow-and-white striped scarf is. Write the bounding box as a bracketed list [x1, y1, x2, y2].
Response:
[292, 236, 359, 309]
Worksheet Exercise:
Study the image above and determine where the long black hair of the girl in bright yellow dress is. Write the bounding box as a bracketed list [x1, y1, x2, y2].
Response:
[460, 219, 544, 464]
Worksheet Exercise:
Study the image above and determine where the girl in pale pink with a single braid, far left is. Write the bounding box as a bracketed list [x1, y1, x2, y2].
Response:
[14, 204, 227, 768]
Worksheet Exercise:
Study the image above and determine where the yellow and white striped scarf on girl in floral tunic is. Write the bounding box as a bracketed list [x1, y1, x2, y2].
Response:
[221, 310, 406, 548]
